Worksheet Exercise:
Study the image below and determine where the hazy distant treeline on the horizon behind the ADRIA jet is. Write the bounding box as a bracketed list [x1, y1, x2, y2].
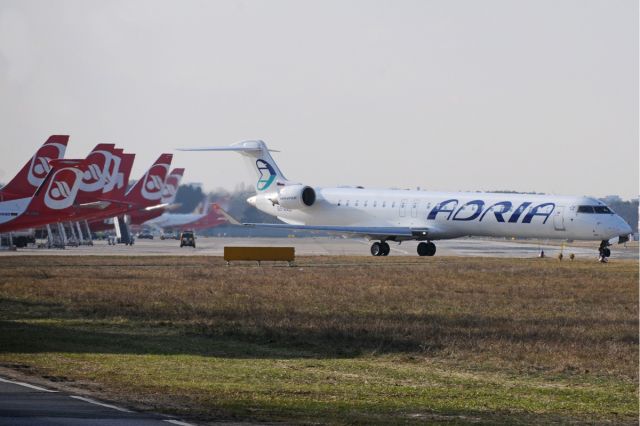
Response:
[176, 184, 638, 235]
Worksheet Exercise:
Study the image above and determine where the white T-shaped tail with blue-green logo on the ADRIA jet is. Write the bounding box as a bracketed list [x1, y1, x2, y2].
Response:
[178, 140, 288, 192]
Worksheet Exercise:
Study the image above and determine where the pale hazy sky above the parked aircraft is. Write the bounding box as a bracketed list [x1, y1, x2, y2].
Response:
[0, 0, 639, 198]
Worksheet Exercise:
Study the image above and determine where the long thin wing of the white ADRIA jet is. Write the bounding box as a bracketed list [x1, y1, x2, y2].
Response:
[243, 223, 429, 240]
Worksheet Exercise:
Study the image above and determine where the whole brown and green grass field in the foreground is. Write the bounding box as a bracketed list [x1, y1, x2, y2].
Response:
[0, 256, 638, 424]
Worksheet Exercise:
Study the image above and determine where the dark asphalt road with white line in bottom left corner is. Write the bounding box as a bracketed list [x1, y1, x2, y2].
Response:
[0, 378, 189, 426]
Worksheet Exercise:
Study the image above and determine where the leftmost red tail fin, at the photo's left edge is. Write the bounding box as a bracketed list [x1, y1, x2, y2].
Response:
[0, 135, 69, 198]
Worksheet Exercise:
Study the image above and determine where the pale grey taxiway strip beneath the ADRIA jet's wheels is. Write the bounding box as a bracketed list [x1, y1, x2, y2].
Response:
[0, 237, 638, 260]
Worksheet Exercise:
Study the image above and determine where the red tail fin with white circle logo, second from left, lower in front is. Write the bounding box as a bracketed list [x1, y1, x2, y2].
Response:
[27, 160, 89, 215]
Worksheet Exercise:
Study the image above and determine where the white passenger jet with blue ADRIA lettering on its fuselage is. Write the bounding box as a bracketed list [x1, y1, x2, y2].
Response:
[181, 140, 631, 259]
